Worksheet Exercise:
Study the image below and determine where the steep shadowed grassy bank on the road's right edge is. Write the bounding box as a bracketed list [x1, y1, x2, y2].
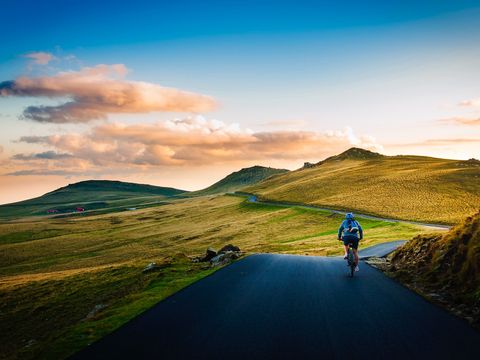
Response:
[390, 213, 480, 328]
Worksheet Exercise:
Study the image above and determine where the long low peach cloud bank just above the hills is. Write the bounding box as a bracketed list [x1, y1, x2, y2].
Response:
[15, 116, 382, 167]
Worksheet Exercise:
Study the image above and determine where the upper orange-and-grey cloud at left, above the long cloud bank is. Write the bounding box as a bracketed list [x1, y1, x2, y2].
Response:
[0, 64, 215, 123]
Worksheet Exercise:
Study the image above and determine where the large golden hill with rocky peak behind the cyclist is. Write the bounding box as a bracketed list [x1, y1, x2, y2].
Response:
[244, 148, 480, 224]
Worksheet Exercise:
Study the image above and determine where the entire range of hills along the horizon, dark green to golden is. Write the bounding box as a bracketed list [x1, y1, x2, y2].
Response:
[0, 147, 480, 224]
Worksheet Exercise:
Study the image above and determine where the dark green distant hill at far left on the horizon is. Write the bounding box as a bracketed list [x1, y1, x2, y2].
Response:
[0, 180, 185, 219]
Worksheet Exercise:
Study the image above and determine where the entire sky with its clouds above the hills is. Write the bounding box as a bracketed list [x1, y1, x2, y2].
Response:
[0, 0, 480, 203]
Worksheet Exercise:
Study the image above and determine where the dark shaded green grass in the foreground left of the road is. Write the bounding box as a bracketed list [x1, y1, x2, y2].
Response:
[0, 256, 216, 359]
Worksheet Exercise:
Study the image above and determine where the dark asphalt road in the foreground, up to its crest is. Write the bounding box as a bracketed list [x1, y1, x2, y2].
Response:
[74, 254, 480, 360]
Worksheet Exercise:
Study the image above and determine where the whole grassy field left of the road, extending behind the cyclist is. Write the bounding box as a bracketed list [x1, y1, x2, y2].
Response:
[0, 196, 442, 359]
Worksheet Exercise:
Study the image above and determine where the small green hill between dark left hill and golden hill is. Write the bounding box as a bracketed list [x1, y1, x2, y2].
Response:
[190, 165, 288, 195]
